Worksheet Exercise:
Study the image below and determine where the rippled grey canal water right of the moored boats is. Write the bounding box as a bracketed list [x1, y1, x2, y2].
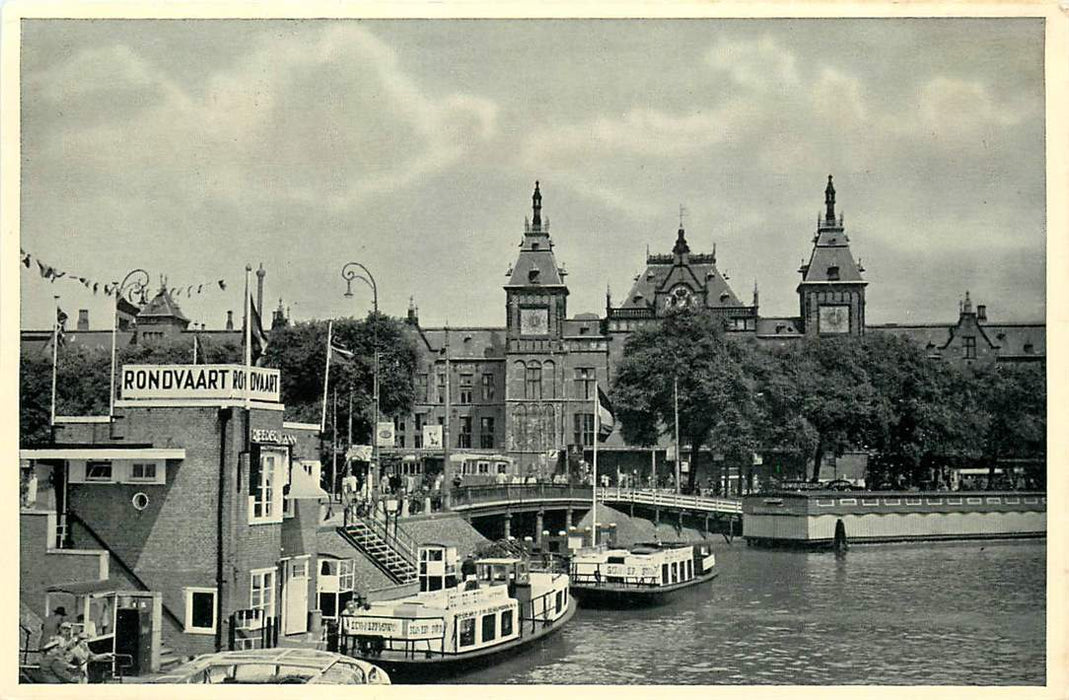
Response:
[450, 540, 1047, 685]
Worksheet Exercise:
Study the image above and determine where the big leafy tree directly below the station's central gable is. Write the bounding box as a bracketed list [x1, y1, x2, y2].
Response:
[611, 310, 757, 489]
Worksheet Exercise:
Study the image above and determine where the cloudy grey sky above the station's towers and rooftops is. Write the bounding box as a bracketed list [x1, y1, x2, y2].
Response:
[20, 18, 1045, 329]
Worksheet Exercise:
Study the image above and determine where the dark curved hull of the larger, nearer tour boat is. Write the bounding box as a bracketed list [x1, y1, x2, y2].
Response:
[339, 595, 576, 685]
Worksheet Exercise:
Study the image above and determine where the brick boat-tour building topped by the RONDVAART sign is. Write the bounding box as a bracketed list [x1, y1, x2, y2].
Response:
[20, 364, 326, 656]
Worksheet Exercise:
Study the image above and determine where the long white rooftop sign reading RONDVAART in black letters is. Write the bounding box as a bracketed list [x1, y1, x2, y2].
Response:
[119, 364, 281, 403]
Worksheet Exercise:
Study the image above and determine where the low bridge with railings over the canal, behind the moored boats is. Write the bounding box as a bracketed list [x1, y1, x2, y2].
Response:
[450, 483, 742, 536]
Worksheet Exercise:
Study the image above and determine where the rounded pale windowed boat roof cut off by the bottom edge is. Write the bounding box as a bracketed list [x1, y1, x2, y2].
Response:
[153, 648, 390, 685]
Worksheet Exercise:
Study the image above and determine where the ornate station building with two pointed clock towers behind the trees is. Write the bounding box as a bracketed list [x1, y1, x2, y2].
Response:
[24, 176, 1045, 483]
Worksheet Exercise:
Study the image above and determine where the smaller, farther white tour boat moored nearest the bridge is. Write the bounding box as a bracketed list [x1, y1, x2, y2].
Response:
[570, 543, 717, 607]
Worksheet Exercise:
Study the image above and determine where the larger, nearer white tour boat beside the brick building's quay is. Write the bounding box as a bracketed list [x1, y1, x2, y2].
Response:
[338, 545, 575, 683]
